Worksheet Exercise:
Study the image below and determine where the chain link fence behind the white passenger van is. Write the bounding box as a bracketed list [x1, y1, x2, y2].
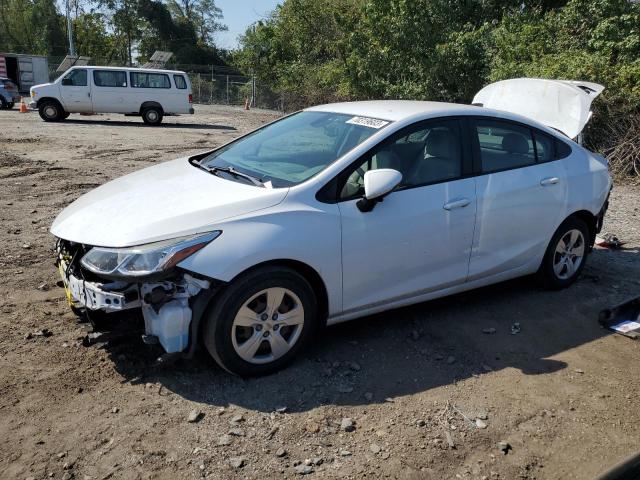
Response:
[48, 57, 283, 110]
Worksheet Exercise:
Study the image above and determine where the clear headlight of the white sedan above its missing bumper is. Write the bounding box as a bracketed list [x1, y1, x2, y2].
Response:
[80, 230, 222, 277]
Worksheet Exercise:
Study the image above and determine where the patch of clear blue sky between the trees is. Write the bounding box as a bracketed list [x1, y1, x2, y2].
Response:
[216, 0, 282, 48]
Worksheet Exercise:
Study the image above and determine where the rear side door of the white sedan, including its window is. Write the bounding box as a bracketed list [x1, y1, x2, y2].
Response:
[469, 117, 567, 281]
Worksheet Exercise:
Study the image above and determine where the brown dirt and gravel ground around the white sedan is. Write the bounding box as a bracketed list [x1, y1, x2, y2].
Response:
[0, 107, 640, 480]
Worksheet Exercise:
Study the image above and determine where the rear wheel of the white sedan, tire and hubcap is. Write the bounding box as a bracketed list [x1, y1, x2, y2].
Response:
[538, 217, 590, 290]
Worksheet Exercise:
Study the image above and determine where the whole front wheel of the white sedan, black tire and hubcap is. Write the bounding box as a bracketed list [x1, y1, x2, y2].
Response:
[203, 267, 319, 377]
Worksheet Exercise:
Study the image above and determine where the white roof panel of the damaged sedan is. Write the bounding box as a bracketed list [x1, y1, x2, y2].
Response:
[305, 100, 486, 122]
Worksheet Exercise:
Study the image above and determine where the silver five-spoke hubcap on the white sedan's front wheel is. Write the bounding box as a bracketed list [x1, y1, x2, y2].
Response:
[231, 287, 304, 364]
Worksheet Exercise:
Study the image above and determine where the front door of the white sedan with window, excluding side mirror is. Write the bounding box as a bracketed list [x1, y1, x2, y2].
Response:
[338, 119, 476, 313]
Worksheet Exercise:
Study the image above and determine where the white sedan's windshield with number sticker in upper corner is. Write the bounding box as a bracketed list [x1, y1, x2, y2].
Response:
[201, 112, 390, 188]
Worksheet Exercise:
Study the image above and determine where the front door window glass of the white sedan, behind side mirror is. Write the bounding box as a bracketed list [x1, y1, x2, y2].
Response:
[340, 120, 462, 199]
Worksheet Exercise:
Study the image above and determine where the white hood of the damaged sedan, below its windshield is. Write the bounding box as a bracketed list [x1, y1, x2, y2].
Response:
[51, 158, 288, 247]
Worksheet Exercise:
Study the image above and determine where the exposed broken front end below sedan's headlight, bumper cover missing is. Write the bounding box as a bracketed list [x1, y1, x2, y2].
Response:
[56, 240, 220, 353]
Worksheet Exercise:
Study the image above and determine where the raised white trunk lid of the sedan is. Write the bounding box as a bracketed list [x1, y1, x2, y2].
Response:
[472, 78, 604, 138]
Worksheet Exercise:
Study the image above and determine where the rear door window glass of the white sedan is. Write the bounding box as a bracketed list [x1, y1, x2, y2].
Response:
[476, 119, 536, 173]
